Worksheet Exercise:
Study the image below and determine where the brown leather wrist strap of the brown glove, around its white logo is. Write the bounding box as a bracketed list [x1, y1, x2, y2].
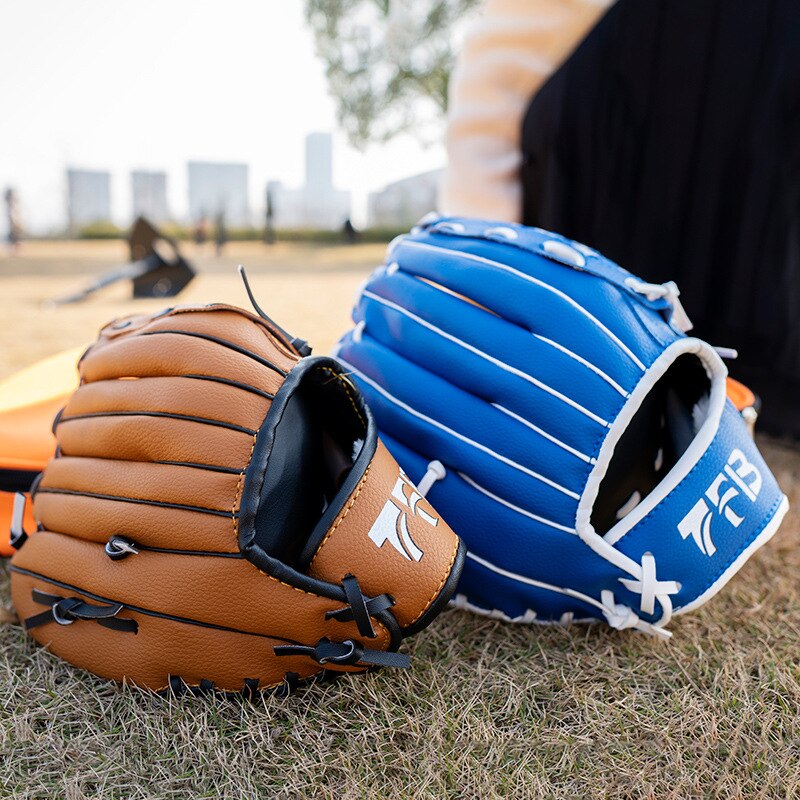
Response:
[309, 442, 458, 627]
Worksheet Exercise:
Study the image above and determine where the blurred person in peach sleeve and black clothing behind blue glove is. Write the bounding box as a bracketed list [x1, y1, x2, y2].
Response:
[440, 0, 800, 439]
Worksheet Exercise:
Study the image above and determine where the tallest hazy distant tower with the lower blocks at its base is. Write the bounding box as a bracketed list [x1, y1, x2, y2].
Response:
[267, 133, 350, 230]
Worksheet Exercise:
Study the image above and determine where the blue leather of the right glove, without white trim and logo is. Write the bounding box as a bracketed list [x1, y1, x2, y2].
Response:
[337, 219, 782, 622]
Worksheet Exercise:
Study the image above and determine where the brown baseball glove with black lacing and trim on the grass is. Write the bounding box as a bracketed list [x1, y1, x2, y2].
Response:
[11, 305, 463, 691]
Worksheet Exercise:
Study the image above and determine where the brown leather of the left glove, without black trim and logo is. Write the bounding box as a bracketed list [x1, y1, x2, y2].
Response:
[11, 306, 457, 691]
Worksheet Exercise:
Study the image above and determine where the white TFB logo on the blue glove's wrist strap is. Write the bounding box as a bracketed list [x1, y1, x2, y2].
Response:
[678, 448, 762, 556]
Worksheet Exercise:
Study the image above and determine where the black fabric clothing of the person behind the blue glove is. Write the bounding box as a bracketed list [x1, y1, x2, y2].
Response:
[521, 0, 800, 437]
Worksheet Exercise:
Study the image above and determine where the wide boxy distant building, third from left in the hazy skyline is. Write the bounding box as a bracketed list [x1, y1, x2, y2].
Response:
[189, 161, 250, 227]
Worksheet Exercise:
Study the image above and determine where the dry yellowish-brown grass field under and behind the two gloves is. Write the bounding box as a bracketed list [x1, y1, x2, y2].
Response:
[0, 242, 800, 800]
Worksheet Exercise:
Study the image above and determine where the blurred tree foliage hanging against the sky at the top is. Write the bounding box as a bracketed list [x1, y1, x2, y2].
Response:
[306, 0, 479, 148]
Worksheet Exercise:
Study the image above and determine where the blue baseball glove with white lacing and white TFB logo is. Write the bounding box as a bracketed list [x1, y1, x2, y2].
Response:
[336, 219, 788, 636]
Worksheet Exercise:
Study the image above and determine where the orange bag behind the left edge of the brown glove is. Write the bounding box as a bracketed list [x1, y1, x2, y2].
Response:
[0, 347, 85, 556]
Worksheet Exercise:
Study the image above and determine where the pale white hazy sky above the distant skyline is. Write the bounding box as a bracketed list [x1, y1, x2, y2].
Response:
[0, 0, 444, 229]
